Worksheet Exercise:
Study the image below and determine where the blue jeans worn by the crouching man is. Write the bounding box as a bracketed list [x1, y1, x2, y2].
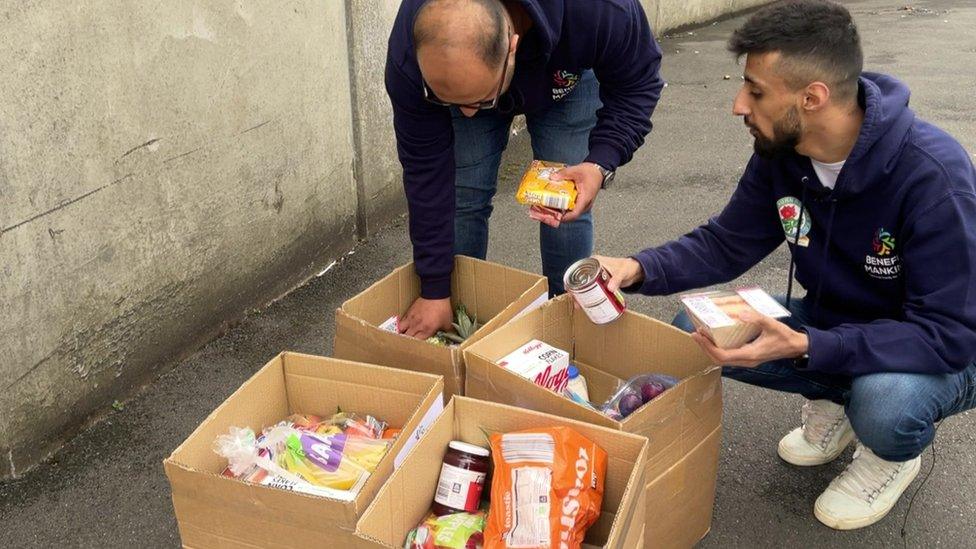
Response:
[672, 298, 976, 461]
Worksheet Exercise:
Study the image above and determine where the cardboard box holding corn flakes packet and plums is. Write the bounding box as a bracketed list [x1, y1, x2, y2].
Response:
[465, 296, 722, 547]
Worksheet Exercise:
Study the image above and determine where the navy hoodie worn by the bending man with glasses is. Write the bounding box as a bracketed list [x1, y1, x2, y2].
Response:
[386, 0, 664, 299]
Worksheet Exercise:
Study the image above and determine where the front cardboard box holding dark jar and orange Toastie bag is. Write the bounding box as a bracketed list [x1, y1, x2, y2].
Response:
[358, 396, 648, 549]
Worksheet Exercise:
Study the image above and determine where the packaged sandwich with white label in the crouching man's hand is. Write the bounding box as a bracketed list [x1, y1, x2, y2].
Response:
[681, 287, 790, 349]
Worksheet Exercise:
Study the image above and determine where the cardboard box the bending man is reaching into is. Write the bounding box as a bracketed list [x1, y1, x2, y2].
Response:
[333, 256, 549, 395]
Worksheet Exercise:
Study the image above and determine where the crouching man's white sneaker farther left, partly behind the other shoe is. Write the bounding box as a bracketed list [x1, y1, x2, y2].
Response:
[777, 400, 854, 467]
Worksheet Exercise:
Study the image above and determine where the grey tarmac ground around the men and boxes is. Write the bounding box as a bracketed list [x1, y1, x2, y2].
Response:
[0, 0, 976, 547]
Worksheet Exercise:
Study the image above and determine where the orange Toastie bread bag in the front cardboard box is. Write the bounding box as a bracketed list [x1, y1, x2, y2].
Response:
[485, 427, 607, 549]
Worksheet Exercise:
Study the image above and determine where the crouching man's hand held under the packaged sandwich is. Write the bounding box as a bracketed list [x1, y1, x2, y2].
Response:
[691, 313, 810, 368]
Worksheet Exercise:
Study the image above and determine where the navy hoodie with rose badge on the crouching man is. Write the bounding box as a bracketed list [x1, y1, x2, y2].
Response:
[635, 73, 976, 375]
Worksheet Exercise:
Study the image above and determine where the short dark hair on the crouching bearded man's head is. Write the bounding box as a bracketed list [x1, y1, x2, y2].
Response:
[728, 0, 864, 101]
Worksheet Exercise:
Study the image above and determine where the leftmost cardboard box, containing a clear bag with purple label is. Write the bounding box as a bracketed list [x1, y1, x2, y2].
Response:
[163, 353, 444, 547]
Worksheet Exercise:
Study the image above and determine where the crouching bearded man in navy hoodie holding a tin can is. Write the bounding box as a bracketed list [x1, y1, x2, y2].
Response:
[599, 0, 976, 529]
